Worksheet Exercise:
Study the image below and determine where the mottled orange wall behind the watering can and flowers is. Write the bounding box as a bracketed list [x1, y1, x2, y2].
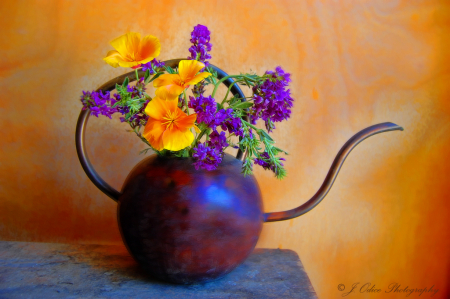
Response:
[0, 0, 450, 298]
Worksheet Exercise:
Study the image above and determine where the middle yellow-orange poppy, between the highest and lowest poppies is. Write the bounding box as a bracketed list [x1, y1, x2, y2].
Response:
[153, 60, 211, 99]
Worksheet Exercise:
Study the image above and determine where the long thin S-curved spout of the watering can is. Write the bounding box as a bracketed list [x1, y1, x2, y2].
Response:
[264, 122, 403, 222]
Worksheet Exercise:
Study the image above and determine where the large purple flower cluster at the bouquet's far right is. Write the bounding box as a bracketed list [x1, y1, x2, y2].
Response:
[250, 67, 294, 132]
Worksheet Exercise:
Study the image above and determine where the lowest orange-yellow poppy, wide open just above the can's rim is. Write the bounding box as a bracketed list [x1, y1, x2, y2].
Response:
[143, 97, 197, 151]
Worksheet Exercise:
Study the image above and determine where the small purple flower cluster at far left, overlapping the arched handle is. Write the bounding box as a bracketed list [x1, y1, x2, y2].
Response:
[81, 90, 117, 118]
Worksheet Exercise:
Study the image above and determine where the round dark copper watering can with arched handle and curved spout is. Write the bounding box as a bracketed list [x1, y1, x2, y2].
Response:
[75, 59, 403, 283]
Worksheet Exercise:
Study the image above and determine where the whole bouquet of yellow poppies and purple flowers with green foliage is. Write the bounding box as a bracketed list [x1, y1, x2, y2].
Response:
[81, 25, 293, 179]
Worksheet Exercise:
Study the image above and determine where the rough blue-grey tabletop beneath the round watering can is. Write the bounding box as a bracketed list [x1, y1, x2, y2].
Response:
[0, 242, 317, 298]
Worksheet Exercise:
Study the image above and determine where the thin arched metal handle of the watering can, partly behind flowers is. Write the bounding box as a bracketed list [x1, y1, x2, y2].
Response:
[75, 59, 245, 201]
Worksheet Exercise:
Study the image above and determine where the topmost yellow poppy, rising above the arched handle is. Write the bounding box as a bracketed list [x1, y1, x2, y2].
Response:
[103, 32, 161, 68]
